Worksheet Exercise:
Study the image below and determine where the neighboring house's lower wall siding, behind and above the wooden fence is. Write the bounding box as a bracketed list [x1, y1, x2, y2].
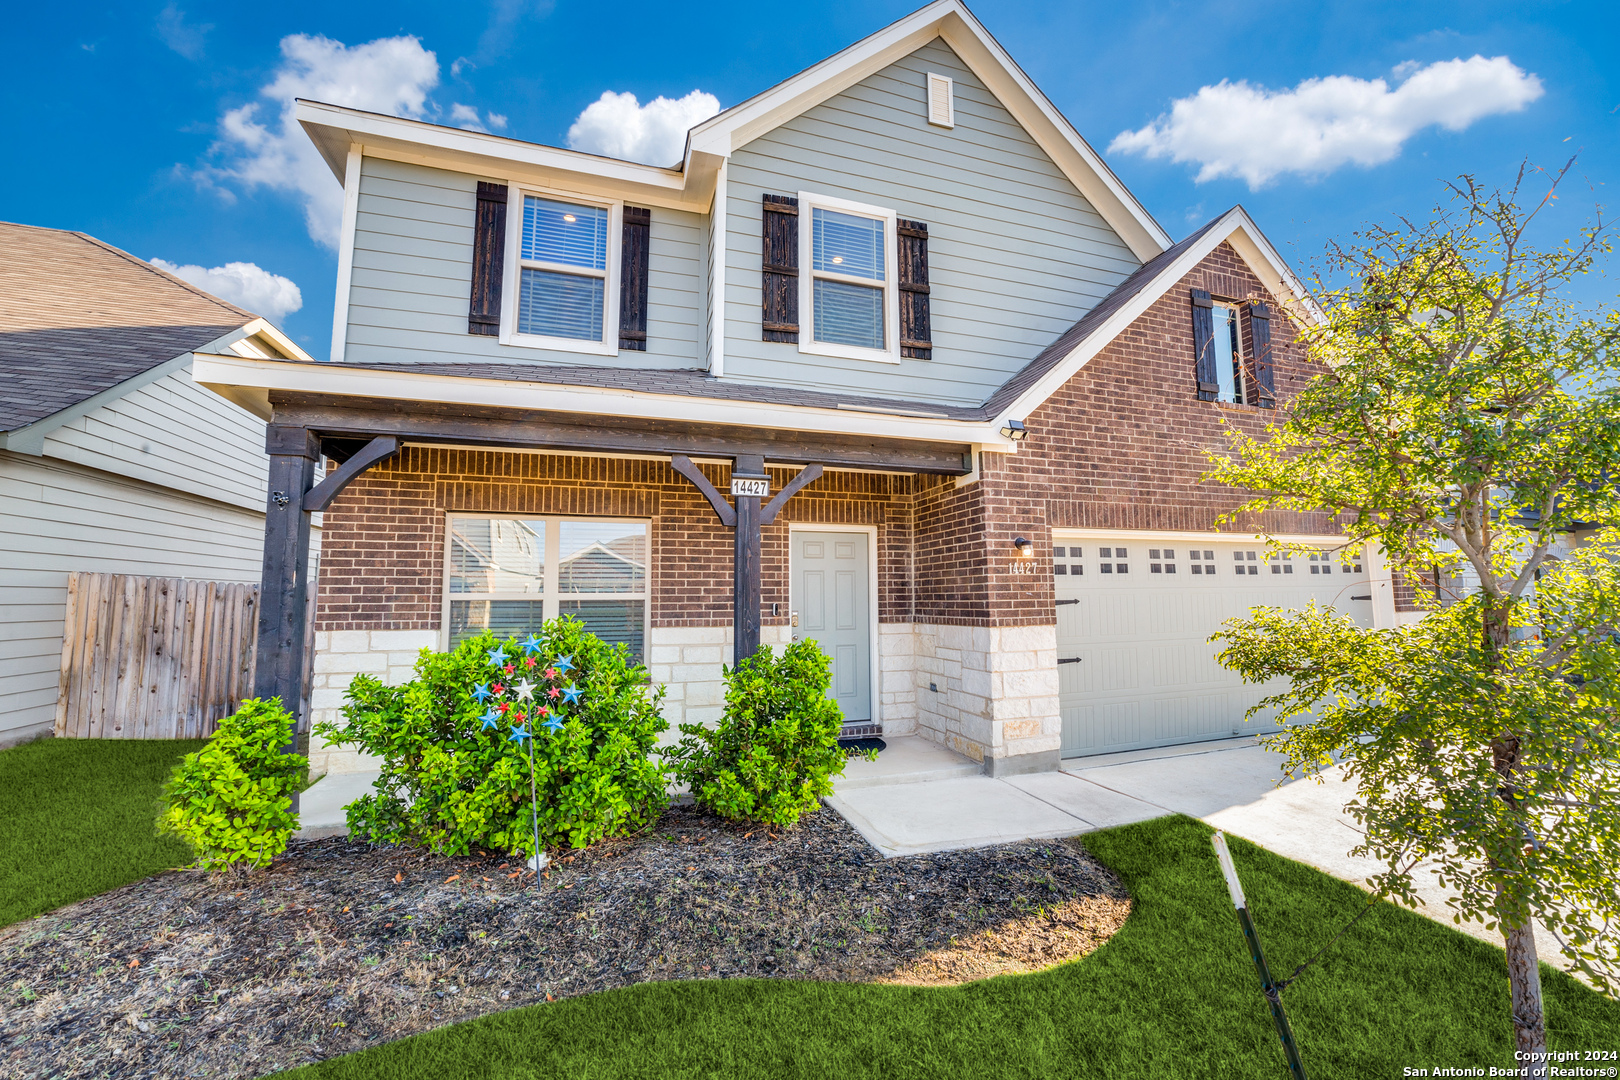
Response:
[0, 450, 319, 745]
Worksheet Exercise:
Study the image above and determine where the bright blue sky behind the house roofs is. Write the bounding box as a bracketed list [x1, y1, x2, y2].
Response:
[0, 0, 1620, 358]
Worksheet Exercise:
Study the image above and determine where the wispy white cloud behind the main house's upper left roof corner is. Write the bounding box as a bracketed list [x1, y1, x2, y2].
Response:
[198, 34, 439, 247]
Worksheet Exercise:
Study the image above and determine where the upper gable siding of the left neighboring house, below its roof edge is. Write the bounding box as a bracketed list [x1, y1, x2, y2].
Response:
[45, 369, 269, 513]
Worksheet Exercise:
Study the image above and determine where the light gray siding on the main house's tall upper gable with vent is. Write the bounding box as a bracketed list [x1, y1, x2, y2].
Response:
[726, 39, 1140, 405]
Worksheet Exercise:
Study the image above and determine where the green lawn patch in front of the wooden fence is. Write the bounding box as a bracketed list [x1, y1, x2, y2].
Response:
[0, 738, 204, 926]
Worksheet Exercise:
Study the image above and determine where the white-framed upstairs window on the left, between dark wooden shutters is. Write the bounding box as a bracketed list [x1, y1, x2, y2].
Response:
[507, 194, 620, 351]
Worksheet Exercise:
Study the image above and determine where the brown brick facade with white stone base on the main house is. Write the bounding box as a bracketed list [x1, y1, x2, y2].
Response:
[316, 244, 1333, 771]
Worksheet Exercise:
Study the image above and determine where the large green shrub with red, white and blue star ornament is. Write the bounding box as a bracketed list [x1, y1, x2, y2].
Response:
[316, 619, 669, 857]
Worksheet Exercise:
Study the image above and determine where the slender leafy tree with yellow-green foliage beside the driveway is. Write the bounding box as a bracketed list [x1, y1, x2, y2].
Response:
[1205, 165, 1620, 1075]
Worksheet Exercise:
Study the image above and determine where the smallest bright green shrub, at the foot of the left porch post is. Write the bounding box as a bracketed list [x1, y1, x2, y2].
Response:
[159, 698, 309, 870]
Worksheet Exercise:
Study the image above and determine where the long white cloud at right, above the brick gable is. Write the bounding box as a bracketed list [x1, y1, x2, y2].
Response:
[1108, 55, 1544, 189]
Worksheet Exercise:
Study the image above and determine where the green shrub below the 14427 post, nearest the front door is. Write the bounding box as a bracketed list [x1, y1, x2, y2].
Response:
[664, 641, 844, 826]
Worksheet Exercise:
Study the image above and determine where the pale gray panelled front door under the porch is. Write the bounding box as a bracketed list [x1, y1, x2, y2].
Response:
[789, 531, 872, 724]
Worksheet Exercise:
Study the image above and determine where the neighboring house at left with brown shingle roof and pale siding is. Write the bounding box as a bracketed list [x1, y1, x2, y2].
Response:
[0, 223, 308, 746]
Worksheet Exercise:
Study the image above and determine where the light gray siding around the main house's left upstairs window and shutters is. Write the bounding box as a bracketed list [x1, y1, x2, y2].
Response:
[343, 157, 703, 368]
